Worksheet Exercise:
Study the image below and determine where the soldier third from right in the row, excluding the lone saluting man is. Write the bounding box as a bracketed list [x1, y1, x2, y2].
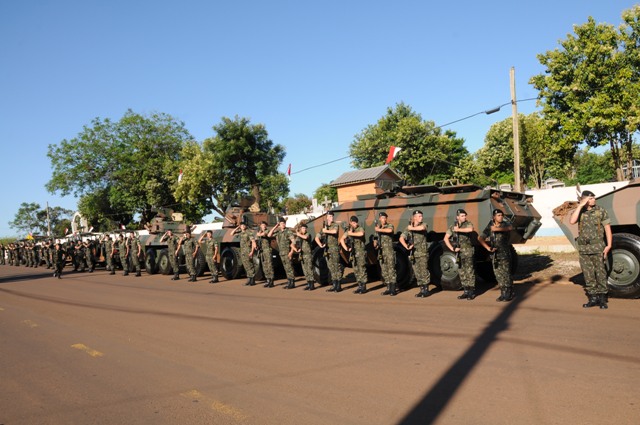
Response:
[400, 210, 431, 298]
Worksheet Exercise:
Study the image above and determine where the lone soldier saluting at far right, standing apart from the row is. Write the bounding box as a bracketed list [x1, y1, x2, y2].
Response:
[570, 190, 613, 309]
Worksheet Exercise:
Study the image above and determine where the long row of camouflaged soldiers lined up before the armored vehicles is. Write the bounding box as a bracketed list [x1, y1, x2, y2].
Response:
[0, 209, 514, 301]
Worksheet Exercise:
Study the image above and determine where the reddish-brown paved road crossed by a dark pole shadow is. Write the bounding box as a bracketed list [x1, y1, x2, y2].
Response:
[0, 266, 640, 425]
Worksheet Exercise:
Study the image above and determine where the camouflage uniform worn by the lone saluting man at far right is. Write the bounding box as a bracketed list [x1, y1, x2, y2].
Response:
[576, 205, 611, 296]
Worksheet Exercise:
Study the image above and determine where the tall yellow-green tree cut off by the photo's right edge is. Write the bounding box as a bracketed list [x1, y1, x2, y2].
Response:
[530, 6, 640, 180]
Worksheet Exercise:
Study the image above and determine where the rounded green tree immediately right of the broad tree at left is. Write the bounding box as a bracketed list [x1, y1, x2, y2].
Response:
[174, 116, 289, 215]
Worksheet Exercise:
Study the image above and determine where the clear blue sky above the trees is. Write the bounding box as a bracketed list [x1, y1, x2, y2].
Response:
[0, 0, 634, 236]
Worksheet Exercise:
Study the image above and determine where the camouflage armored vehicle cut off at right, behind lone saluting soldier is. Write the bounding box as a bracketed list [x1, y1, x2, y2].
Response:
[553, 180, 640, 298]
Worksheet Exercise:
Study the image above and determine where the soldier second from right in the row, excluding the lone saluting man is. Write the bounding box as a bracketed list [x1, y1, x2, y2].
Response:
[444, 209, 476, 300]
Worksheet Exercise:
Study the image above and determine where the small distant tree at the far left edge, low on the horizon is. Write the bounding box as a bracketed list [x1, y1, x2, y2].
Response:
[9, 202, 73, 235]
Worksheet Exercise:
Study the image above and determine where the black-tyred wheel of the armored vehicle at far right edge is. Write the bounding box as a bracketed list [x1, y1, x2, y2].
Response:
[608, 233, 640, 298]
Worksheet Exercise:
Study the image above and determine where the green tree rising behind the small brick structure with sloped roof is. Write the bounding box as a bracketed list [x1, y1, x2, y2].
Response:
[350, 103, 468, 184]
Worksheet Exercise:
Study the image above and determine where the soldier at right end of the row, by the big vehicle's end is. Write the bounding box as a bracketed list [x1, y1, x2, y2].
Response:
[478, 208, 515, 301]
